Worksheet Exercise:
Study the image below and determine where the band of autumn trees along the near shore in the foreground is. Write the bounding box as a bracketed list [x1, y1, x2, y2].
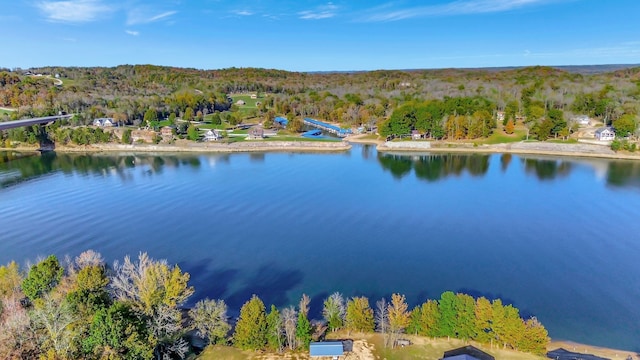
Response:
[0, 250, 549, 359]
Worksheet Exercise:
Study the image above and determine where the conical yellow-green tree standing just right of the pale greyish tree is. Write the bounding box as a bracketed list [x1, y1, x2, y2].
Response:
[233, 295, 267, 350]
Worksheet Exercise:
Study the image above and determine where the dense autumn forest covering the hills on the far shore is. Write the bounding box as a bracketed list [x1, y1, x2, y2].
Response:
[0, 65, 640, 145]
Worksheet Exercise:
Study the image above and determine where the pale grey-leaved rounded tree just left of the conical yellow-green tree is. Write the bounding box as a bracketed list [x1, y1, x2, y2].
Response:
[189, 299, 231, 344]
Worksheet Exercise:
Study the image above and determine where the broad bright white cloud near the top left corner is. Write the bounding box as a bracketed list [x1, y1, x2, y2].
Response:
[36, 0, 114, 23]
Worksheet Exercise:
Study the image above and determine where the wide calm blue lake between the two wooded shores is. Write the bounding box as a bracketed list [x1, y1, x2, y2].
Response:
[0, 145, 640, 351]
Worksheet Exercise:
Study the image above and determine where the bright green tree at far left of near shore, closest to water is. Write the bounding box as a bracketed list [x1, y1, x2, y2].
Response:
[22, 255, 64, 301]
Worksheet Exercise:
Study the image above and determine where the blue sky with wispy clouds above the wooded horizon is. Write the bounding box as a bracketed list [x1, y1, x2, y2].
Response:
[0, 0, 640, 71]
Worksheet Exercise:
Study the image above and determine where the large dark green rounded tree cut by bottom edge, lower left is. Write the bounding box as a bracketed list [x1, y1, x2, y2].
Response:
[82, 302, 154, 360]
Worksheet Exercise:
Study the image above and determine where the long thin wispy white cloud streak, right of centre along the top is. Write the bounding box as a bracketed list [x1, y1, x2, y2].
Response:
[361, 0, 566, 22]
